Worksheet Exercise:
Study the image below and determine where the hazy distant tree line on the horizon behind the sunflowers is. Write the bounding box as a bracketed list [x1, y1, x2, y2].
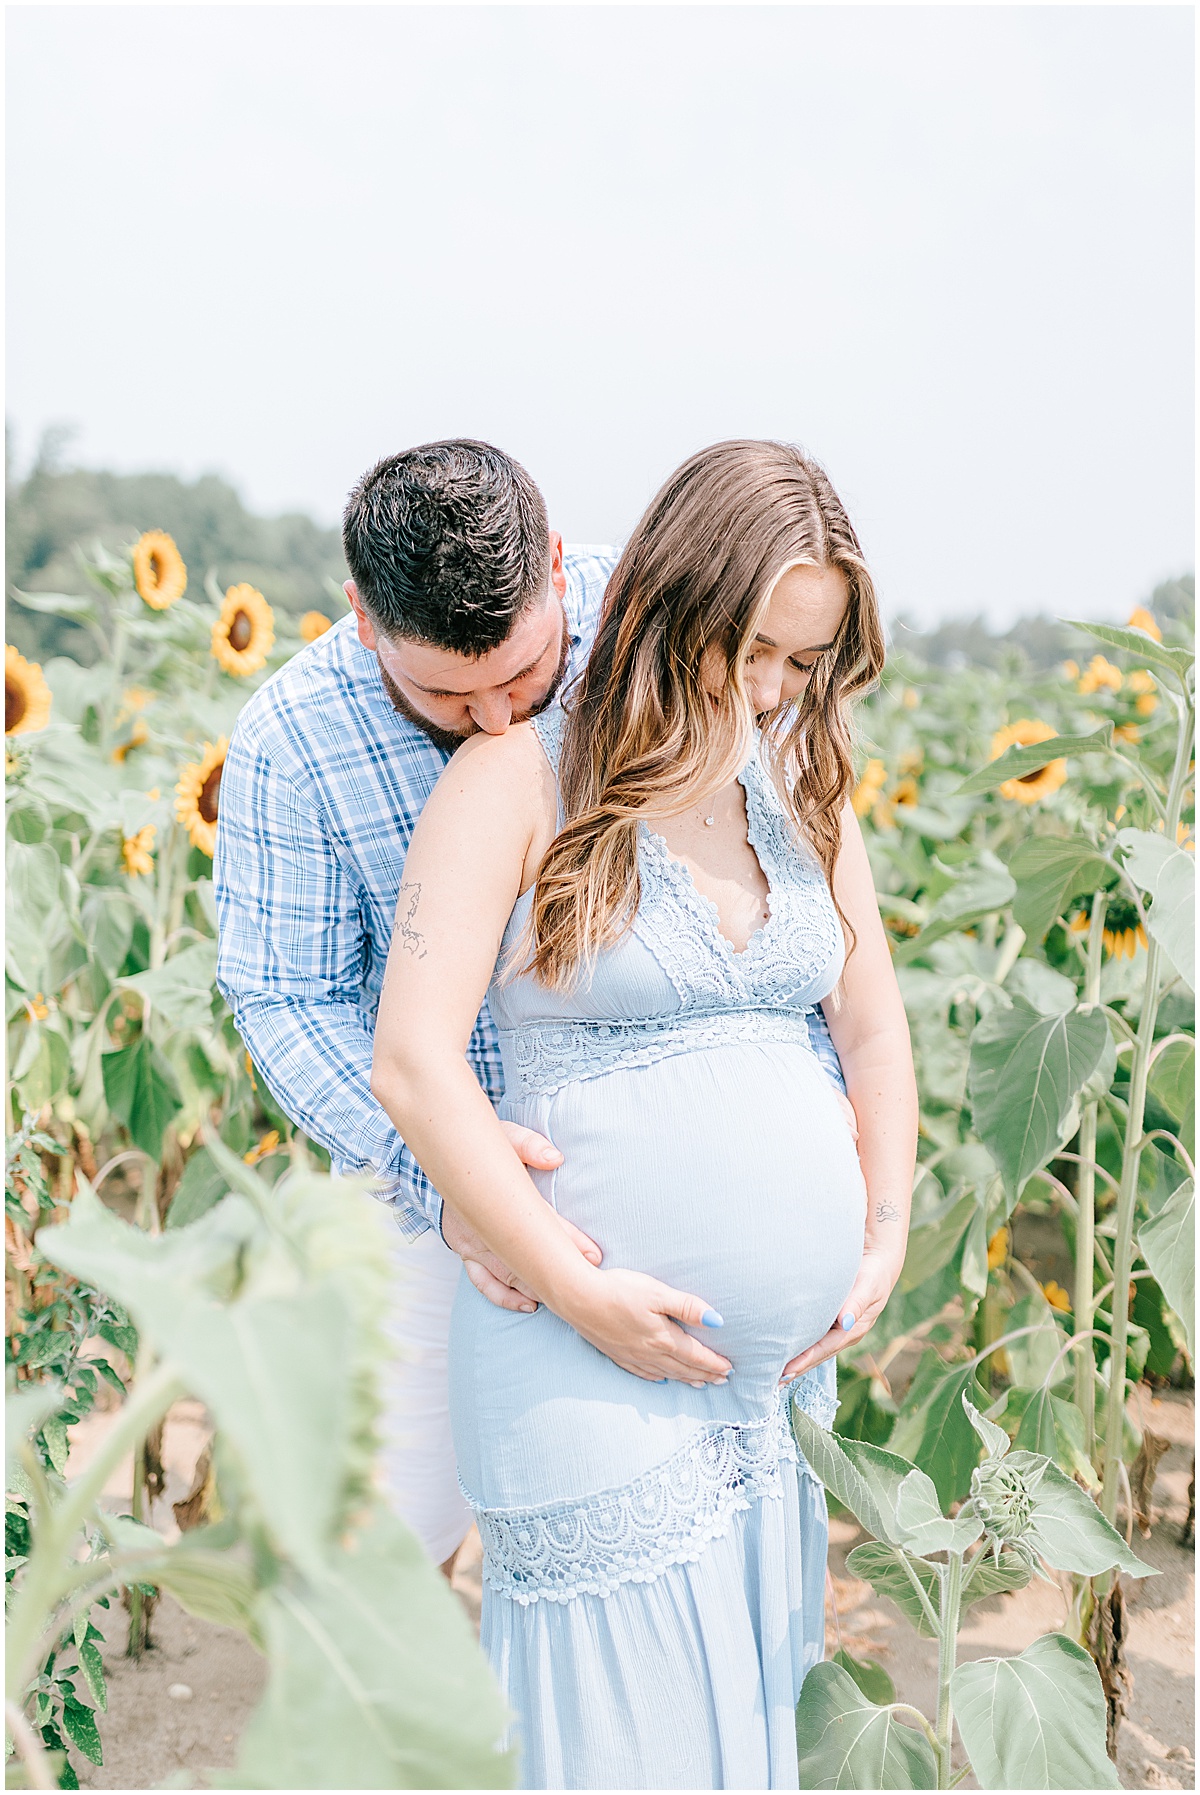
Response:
[5, 431, 1196, 675]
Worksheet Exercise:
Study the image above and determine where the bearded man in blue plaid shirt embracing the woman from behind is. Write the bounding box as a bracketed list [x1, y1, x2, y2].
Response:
[213, 442, 836, 1567]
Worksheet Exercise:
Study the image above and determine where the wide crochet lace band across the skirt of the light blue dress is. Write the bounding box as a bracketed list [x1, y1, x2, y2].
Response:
[463, 1361, 838, 1607]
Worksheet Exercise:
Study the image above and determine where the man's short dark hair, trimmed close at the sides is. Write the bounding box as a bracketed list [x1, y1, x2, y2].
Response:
[343, 442, 549, 655]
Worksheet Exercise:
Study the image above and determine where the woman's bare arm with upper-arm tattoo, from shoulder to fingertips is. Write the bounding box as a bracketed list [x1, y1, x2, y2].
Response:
[371, 725, 728, 1382]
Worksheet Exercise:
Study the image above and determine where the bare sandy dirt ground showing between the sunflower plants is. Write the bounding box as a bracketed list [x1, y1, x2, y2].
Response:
[75, 1386, 1196, 1790]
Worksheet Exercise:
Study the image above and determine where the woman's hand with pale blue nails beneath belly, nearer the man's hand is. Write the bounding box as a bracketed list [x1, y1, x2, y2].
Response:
[549, 1265, 732, 1389]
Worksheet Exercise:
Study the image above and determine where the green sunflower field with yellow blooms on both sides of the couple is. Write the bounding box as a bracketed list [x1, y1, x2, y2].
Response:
[5, 531, 1195, 1788]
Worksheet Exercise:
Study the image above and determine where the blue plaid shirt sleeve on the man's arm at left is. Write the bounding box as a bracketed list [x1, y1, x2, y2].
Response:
[213, 732, 441, 1235]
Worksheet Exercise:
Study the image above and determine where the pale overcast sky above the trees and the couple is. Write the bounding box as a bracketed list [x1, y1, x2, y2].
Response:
[7, 5, 1193, 623]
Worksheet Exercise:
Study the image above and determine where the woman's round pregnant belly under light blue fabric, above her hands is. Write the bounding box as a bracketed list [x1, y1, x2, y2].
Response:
[513, 1043, 865, 1400]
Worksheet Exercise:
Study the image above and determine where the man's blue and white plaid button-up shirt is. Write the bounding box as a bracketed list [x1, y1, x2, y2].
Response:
[213, 547, 841, 1235]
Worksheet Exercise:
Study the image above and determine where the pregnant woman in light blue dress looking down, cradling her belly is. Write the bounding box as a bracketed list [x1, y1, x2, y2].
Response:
[373, 442, 917, 1790]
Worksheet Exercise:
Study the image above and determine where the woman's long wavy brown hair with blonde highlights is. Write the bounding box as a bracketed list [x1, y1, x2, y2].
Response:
[529, 442, 884, 989]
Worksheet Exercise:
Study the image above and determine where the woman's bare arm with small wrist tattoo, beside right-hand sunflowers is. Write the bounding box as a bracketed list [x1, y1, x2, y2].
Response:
[784, 804, 917, 1379]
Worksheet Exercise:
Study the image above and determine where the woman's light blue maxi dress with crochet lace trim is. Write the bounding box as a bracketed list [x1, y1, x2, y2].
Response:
[450, 711, 865, 1790]
